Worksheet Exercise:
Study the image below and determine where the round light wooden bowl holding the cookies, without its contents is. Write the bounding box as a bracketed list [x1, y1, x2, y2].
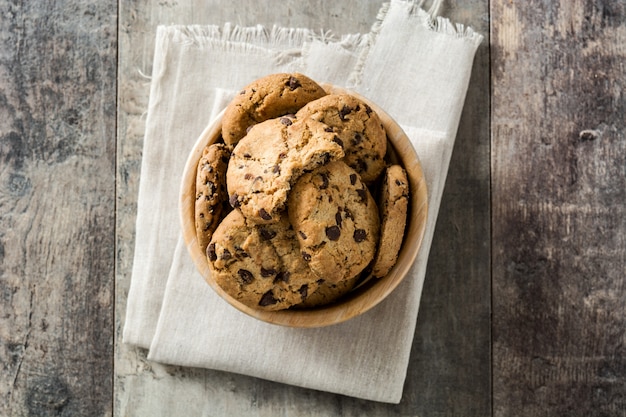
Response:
[180, 84, 428, 327]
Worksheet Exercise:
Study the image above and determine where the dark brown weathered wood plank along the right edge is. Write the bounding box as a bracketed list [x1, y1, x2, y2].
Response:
[491, 0, 626, 416]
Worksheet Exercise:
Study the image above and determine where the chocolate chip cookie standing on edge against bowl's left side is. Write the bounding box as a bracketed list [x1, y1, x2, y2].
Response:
[195, 143, 230, 251]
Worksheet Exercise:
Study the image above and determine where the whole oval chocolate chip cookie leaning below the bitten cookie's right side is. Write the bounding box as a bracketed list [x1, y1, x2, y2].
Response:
[287, 161, 380, 283]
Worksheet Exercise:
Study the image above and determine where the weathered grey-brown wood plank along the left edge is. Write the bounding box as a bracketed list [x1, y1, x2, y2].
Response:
[0, 0, 117, 416]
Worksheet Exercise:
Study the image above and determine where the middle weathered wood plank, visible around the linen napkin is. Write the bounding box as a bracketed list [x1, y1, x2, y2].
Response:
[114, 0, 491, 416]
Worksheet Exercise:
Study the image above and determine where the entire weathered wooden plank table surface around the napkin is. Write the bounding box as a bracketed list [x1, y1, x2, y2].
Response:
[0, 0, 626, 417]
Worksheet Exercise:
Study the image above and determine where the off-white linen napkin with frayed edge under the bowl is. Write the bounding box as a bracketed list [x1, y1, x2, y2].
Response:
[124, 0, 482, 403]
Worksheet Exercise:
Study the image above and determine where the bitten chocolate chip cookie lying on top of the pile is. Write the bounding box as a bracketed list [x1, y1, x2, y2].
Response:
[226, 116, 344, 223]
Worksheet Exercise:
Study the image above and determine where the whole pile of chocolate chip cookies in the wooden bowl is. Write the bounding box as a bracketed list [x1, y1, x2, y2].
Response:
[195, 73, 409, 311]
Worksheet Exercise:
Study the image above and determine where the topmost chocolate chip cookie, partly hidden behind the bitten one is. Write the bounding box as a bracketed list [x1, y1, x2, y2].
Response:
[222, 73, 326, 145]
